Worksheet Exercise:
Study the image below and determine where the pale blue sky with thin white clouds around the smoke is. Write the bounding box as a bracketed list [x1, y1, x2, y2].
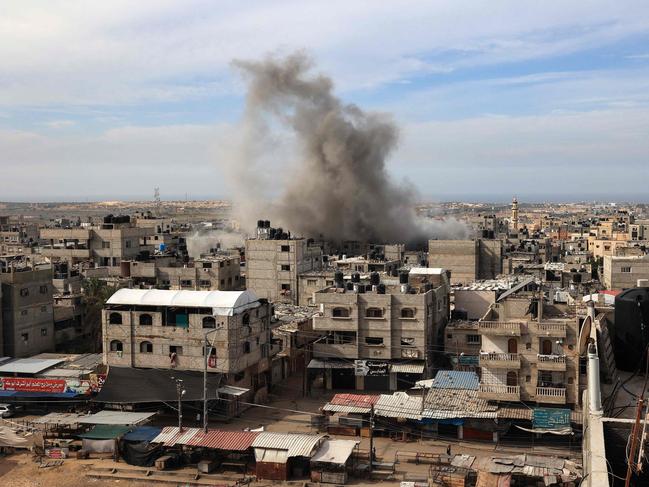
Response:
[0, 0, 649, 201]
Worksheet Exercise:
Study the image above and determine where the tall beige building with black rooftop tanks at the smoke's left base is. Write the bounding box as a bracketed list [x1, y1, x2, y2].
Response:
[245, 220, 322, 304]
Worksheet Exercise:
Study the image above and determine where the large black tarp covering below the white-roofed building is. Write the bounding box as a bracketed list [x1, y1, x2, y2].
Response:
[94, 366, 220, 404]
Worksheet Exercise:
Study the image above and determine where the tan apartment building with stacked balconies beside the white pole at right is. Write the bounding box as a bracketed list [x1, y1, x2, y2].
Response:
[468, 293, 579, 405]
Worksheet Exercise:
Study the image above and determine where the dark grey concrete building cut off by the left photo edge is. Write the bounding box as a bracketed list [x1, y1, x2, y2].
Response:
[0, 260, 54, 358]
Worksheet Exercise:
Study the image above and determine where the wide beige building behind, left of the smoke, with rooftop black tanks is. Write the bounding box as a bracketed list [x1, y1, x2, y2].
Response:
[40, 215, 154, 268]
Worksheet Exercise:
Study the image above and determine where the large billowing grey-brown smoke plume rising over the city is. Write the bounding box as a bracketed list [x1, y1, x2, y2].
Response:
[225, 53, 468, 243]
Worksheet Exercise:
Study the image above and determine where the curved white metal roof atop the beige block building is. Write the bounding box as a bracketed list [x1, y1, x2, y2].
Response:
[106, 289, 259, 316]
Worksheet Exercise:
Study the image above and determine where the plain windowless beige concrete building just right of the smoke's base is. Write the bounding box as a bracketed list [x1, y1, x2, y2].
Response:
[428, 238, 503, 284]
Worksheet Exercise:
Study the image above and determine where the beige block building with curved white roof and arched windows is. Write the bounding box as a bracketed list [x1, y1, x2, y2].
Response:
[102, 289, 272, 391]
